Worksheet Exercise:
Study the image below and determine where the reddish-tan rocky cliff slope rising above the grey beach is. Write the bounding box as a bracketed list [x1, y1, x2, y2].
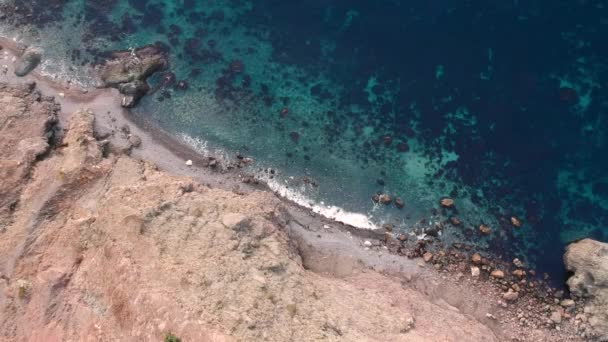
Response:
[0, 85, 504, 341]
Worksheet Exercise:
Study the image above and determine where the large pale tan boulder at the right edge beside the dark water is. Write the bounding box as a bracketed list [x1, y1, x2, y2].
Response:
[564, 239, 608, 341]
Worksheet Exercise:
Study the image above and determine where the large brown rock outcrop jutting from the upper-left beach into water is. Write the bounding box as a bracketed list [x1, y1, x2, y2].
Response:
[100, 45, 169, 108]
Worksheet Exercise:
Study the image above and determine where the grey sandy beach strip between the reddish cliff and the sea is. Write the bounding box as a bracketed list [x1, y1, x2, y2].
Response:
[0, 38, 592, 340]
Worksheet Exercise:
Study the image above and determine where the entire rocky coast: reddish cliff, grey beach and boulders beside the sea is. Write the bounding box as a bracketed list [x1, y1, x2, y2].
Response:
[0, 38, 608, 341]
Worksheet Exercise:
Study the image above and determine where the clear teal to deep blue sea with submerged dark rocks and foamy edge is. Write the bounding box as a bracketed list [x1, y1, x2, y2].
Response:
[0, 0, 608, 280]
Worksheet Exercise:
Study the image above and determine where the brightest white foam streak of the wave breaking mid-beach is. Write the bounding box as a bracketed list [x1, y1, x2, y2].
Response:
[265, 179, 379, 229]
